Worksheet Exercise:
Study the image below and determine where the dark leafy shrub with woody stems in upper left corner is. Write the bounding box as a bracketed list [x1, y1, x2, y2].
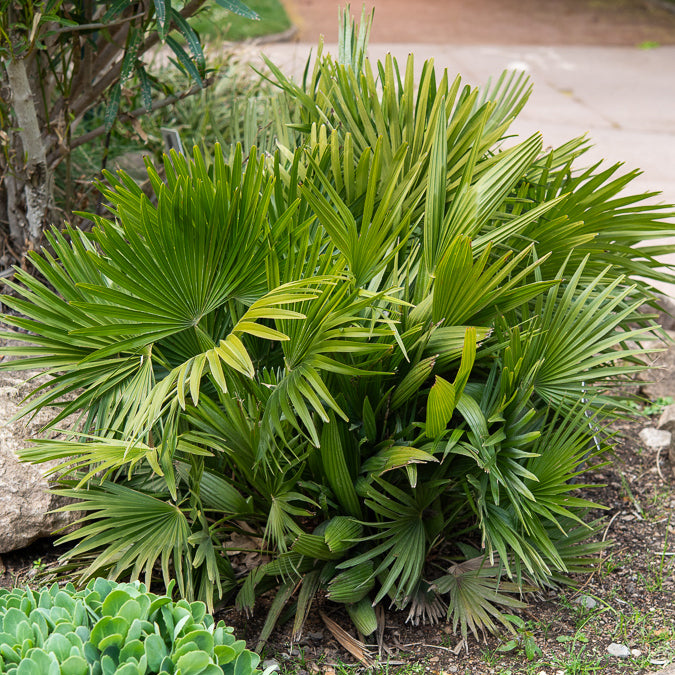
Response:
[0, 0, 258, 252]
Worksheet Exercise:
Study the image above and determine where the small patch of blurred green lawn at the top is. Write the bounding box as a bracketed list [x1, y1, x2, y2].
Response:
[192, 0, 291, 42]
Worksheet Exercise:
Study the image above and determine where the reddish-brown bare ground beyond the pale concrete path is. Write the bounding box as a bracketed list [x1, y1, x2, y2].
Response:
[283, 0, 675, 47]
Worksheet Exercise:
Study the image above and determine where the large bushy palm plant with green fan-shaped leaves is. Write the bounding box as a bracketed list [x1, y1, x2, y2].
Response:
[0, 9, 672, 640]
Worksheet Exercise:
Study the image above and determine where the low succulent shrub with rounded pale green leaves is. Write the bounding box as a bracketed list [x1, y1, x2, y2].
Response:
[0, 579, 260, 675]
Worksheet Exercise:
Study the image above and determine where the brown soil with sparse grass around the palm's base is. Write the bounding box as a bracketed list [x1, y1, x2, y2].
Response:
[0, 394, 675, 675]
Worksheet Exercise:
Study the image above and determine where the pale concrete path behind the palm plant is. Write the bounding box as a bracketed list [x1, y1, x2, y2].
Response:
[263, 43, 675, 298]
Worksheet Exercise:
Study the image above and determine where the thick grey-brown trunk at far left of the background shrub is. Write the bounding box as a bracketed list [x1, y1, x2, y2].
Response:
[5, 58, 52, 251]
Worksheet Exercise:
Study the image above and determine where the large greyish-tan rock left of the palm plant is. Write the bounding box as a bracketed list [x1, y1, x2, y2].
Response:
[0, 373, 79, 553]
